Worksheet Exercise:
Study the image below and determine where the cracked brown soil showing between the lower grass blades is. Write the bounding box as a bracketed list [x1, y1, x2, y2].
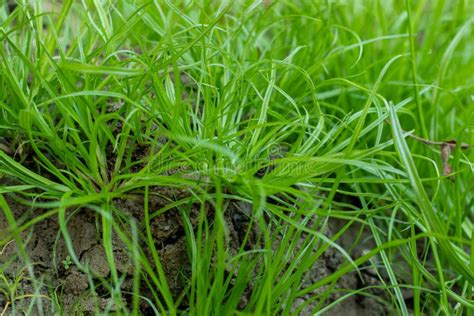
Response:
[0, 180, 387, 315]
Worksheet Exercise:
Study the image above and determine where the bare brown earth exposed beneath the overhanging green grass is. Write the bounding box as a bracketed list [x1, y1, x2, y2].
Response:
[0, 175, 396, 315]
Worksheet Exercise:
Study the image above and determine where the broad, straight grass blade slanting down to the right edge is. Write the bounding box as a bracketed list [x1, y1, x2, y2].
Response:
[386, 104, 474, 286]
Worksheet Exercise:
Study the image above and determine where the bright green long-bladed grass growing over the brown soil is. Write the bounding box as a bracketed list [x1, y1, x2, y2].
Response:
[0, 0, 474, 315]
